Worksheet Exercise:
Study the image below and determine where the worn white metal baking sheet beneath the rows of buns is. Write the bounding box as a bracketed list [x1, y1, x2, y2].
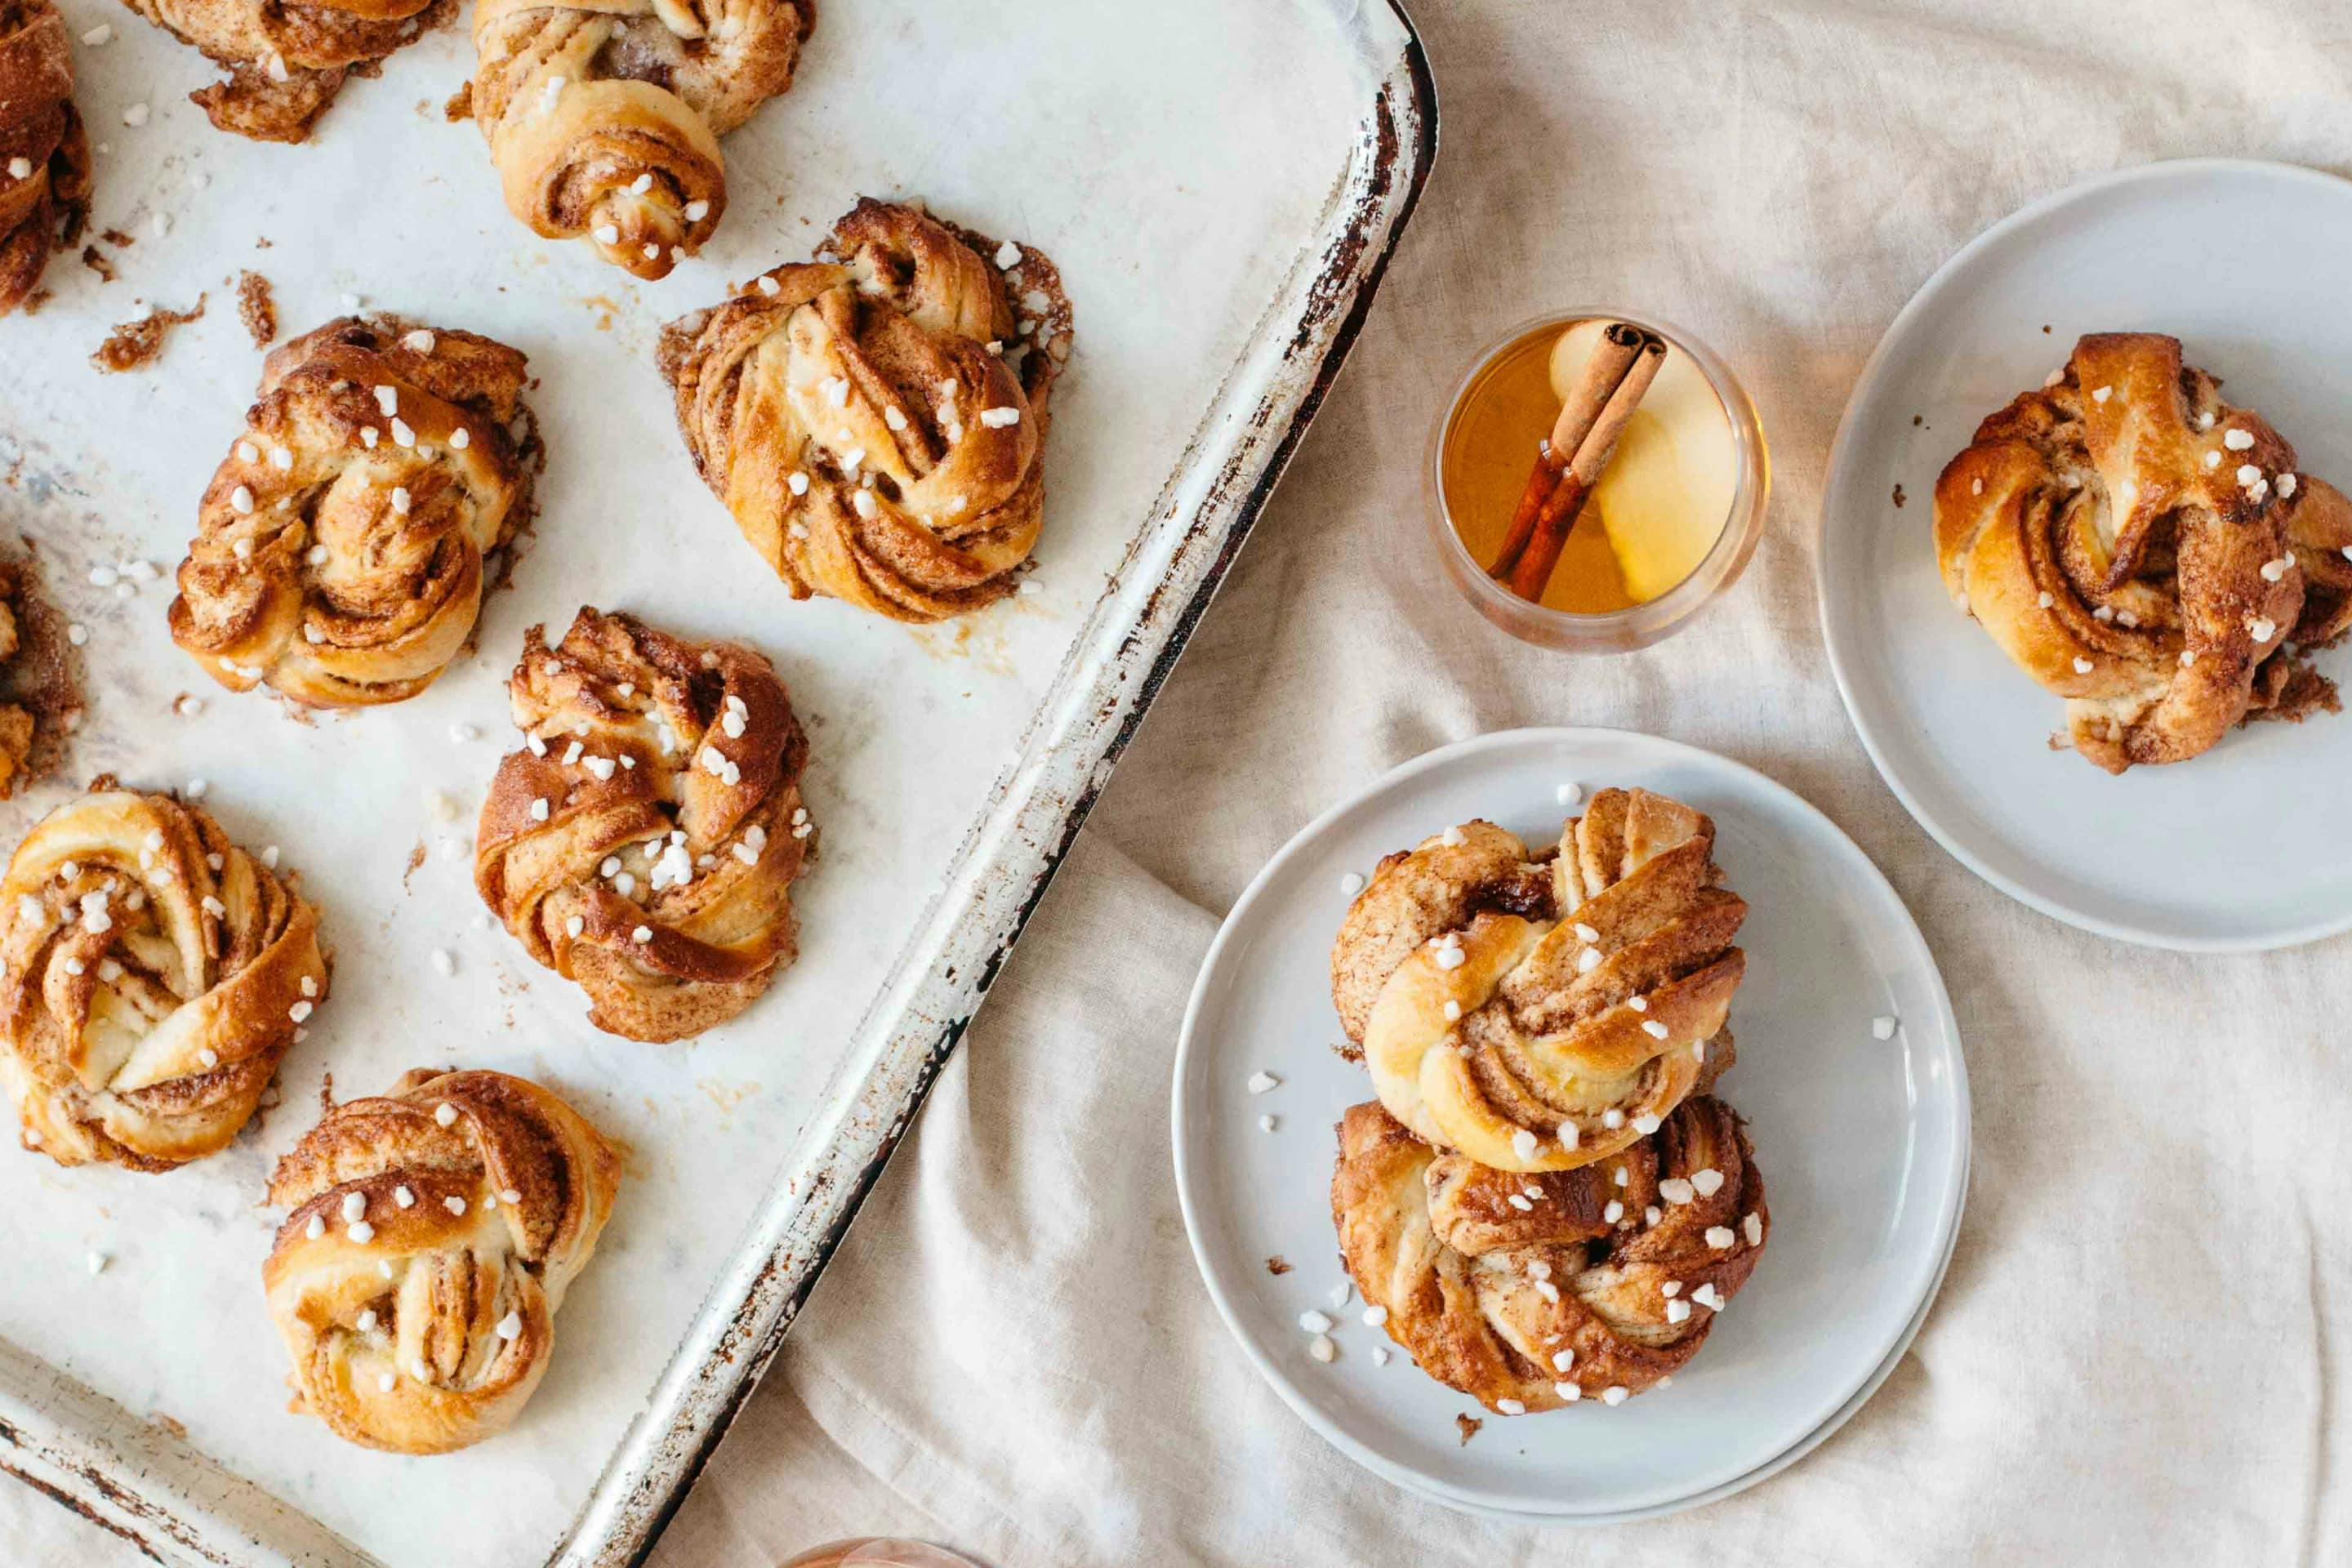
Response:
[0, 0, 1437, 1568]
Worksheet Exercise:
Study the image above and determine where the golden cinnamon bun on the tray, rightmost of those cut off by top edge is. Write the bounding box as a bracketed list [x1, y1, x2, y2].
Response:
[473, 0, 816, 278]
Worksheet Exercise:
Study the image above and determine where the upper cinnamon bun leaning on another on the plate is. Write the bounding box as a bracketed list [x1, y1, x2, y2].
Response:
[1331, 790, 1748, 1171]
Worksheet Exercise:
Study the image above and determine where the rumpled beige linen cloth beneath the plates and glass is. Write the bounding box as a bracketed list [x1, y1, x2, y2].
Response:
[18, 0, 2352, 1568]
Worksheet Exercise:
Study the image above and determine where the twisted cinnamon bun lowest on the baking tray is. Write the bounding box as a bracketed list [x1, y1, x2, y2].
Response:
[261, 1067, 621, 1453]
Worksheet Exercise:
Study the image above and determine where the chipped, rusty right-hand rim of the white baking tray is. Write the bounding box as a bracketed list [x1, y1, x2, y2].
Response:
[564, 0, 1437, 1568]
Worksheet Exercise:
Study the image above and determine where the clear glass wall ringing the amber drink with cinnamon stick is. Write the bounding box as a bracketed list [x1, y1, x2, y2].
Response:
[1423, 308, 1771, 653]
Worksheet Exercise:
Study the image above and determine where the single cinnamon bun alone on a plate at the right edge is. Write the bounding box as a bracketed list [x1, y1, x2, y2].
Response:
[1936, 332, 2352, 773]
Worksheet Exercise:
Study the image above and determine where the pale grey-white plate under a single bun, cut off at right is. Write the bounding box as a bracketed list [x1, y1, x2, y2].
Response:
[1818, 160, 2352, 950]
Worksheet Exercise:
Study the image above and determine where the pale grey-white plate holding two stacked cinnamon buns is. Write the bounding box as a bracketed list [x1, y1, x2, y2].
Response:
[1171, 728, 1969, 1521]
